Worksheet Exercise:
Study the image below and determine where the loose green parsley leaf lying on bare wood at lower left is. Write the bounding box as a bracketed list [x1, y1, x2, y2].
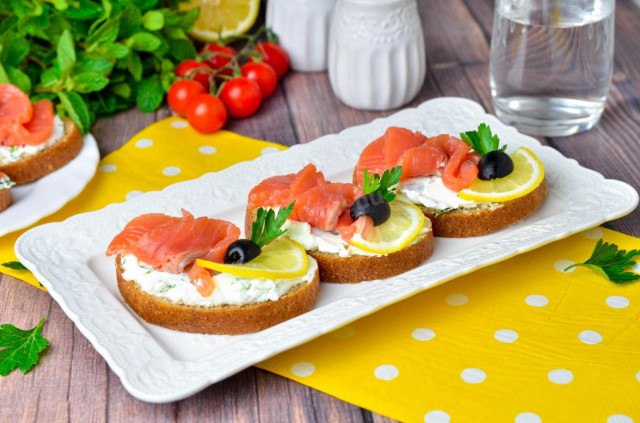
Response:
[0, 317, 49, 376]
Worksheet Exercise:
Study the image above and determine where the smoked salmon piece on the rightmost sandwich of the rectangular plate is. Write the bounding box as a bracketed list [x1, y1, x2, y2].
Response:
[354, 127, 480, 191]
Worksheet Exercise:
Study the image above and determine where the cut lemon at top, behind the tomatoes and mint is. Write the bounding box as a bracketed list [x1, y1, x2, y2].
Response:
[179, 0, 260, 41]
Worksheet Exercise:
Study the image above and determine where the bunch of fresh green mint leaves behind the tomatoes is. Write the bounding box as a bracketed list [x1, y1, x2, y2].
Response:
[0, 0, 198, 133]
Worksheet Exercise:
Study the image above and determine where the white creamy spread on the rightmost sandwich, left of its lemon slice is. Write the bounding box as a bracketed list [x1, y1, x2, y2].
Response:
[400, 176, 478, 210]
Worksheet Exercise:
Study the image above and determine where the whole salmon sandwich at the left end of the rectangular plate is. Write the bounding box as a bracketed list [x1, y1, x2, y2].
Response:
[107, 208, 319, 335]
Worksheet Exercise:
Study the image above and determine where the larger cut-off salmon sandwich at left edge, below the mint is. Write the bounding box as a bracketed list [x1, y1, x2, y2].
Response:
[0, 84, 83, 185]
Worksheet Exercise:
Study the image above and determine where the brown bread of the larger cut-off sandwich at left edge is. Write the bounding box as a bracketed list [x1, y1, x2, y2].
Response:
[0, 119, 83, 185]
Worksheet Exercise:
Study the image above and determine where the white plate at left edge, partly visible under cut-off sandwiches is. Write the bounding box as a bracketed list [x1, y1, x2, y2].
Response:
[0, 134, 100, 236]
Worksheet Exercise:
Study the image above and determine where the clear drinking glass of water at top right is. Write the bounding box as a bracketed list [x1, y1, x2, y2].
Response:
[489, 0, 615, 137]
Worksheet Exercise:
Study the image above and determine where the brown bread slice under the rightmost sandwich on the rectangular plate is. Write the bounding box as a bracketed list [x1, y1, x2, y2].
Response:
[418, 179, 547, 238]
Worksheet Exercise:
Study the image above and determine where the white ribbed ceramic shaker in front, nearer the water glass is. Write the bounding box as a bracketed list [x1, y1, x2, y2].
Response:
[329, 0, 426, 110]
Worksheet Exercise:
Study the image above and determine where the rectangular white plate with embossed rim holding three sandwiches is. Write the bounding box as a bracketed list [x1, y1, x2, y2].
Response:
[16, 98, 638, 402]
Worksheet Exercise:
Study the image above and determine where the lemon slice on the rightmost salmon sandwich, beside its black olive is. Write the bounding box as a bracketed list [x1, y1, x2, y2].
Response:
[458, 147, 544, 202]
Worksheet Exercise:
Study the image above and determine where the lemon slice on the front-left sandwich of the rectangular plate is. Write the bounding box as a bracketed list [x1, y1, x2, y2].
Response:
[196, 236, 308, 279]
